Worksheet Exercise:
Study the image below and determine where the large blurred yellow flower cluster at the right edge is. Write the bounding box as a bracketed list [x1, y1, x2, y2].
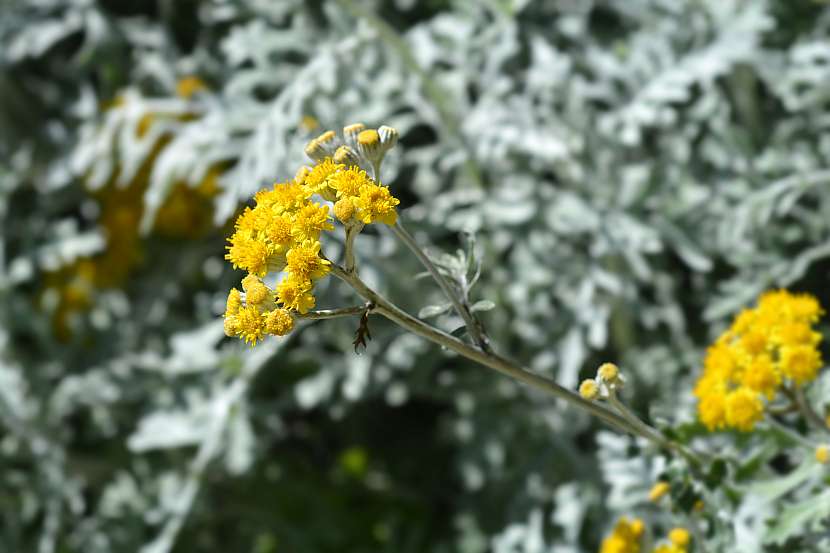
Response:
[694, 290, 823, 432]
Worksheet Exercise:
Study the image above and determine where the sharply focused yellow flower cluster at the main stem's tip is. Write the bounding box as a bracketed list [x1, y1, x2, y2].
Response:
[225, 125, 399, 344]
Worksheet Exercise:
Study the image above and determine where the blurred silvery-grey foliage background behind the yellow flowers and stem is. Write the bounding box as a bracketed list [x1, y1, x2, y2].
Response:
[0, 0, 830, 553]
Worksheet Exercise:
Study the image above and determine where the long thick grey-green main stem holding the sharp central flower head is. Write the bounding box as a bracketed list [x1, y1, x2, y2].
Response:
[331, 263, 700, 454]
